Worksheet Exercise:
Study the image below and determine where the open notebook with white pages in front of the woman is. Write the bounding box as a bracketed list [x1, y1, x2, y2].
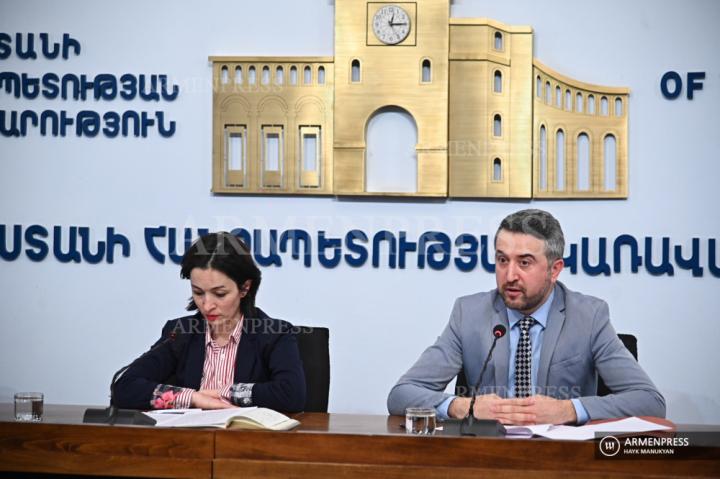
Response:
[145, 407, 300, 431]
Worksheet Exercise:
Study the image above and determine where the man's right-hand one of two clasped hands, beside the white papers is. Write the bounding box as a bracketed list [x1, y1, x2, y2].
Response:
[491, 395, 577, 425]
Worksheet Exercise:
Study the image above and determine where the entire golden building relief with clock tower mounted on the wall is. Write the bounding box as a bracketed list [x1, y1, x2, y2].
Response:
[210, 0, 629, 199]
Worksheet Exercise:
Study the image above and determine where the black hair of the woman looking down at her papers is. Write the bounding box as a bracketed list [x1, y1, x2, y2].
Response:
[180, 231, 261, 318]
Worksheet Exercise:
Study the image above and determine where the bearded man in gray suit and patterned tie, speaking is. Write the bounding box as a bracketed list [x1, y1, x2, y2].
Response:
[388, 209, 665, 424]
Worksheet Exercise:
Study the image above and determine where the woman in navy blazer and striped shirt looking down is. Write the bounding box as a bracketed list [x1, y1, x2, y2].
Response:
[113, 233, 305, 412]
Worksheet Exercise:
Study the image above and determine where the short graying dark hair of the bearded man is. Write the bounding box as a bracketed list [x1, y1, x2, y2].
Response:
[495, 209, 565, 263]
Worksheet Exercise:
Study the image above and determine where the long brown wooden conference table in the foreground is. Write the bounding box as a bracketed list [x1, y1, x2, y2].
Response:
[0, 404, 720, 479]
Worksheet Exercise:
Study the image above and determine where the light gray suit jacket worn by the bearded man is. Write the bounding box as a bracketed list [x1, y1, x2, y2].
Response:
[388, 282, 665, 419]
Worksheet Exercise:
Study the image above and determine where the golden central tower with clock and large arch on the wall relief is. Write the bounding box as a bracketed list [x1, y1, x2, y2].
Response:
[333, 0, 450, 197]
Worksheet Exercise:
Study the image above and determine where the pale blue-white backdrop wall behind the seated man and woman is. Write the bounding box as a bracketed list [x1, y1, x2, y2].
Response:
[0, 0, 720, 423]
